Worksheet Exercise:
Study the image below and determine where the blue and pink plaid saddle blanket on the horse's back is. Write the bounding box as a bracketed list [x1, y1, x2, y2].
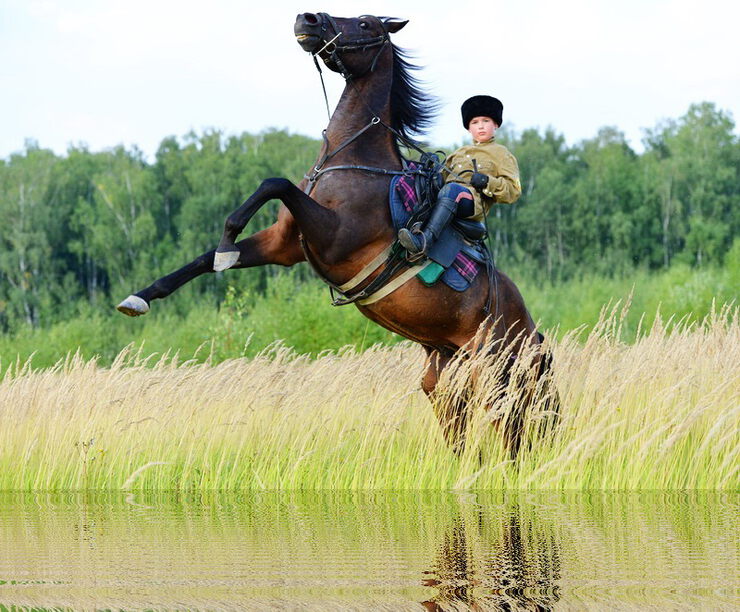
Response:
[388, 165, 488, 291]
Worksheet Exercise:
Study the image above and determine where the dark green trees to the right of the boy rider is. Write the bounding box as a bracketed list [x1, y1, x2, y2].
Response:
[500, 102, 740, 280]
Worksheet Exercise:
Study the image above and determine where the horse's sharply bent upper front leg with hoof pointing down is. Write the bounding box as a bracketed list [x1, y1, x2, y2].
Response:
[213, 178, 339, 272]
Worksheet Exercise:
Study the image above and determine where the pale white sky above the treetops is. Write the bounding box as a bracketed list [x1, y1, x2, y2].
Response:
[0, 0, 740, 158]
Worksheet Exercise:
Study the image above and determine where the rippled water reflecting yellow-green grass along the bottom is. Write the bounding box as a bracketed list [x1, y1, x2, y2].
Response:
[0, 491, 740, 610]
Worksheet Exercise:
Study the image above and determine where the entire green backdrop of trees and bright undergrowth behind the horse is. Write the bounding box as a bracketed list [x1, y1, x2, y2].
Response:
[0, 102, 740, 364]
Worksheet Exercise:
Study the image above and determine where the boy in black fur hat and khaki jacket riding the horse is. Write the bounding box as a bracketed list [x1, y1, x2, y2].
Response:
[398, 96, 522, 255]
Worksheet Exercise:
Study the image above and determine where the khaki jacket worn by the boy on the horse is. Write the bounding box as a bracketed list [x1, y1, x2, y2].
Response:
[442, 139, 522, 221]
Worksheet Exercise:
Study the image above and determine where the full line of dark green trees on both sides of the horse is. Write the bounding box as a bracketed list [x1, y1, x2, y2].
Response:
[0, 103, 740, 332]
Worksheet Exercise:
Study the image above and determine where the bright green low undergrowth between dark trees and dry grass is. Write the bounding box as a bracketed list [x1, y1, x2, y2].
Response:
[0, 257, 740, 371]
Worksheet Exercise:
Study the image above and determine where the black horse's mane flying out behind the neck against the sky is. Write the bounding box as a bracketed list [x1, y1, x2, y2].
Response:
[391, 44, 439, 146]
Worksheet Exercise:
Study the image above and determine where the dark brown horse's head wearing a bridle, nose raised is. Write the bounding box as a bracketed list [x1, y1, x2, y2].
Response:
[294, 13, 408, 79]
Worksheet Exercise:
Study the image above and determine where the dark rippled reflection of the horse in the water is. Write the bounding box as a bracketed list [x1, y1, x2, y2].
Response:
[421, 506, 560, 611]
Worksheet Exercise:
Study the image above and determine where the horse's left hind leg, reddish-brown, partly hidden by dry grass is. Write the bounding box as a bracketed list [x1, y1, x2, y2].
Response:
[421, 346, 468, 456]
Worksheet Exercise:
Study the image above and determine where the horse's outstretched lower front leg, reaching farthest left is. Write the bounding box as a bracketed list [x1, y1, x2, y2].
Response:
[117, 208, 305, 317]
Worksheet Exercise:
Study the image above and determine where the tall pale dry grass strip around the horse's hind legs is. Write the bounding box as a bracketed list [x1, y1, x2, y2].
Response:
[0, 307, 740, 490]
